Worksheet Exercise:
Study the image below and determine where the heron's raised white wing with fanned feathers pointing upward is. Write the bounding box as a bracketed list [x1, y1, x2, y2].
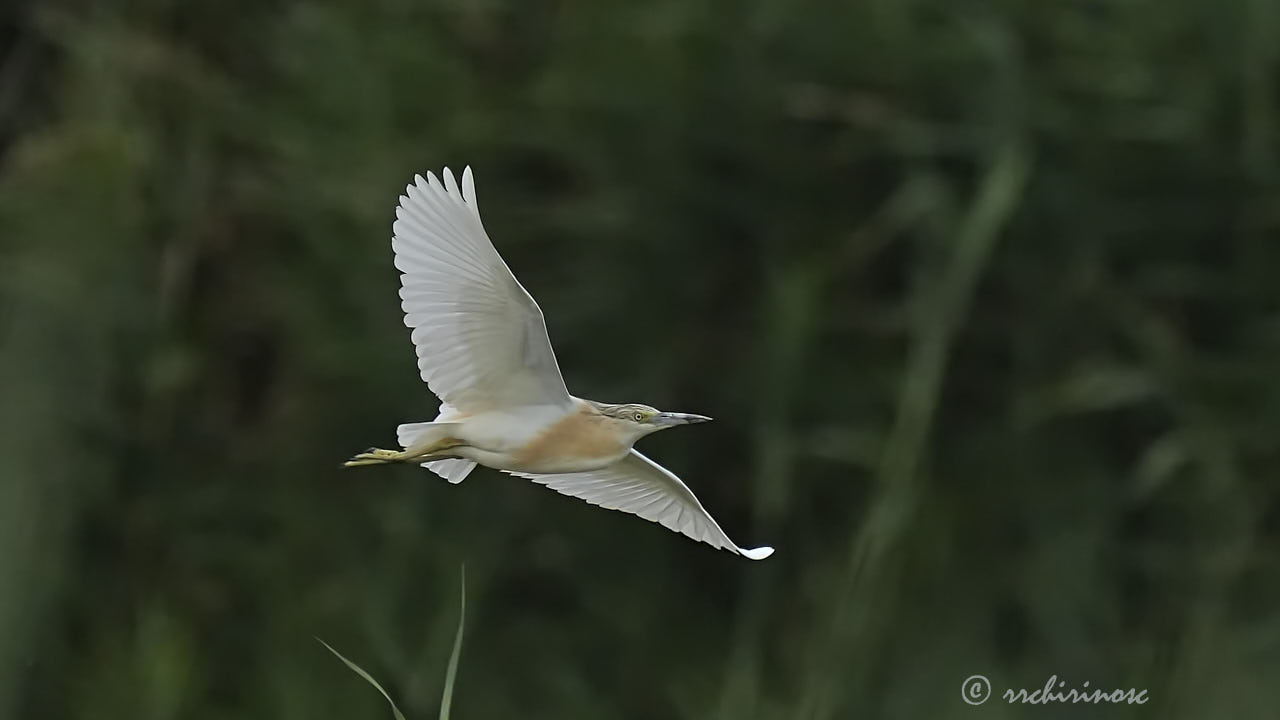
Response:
[392, 168, 570, 414]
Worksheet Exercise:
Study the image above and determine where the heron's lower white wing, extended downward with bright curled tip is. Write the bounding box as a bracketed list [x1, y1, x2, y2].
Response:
[511, 450, 773, 560]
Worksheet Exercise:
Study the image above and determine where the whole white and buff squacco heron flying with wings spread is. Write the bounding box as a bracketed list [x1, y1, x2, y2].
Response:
[347, 168, 773, 560]
